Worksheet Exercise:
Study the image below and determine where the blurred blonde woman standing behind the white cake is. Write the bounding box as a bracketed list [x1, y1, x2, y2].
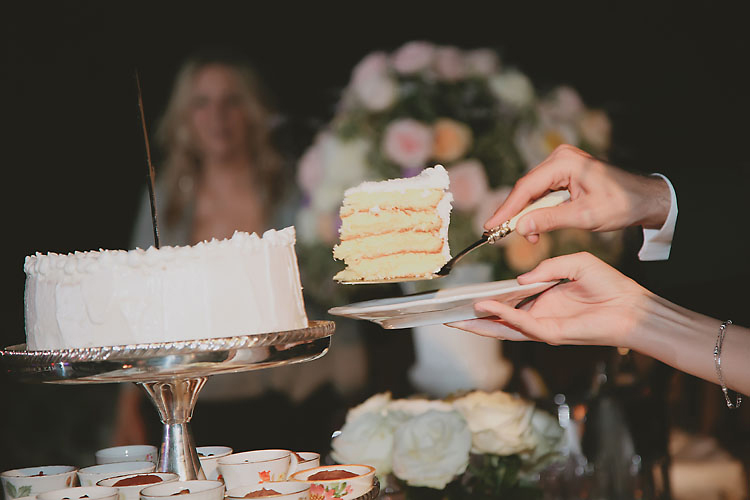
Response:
[112, 47, 368, 451]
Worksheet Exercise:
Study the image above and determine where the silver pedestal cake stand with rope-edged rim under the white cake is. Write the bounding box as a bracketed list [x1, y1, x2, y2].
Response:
[0, 321, 335, 480]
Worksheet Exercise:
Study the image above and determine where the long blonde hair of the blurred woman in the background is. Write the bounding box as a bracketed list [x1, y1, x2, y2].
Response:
[156, 48, 282, 224]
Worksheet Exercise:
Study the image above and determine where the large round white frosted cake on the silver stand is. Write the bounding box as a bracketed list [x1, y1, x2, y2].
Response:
[24, 227, 307, 350]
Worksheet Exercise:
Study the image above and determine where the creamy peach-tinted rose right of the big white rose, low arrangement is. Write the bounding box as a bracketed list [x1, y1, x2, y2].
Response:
[453, 391, 534, 455]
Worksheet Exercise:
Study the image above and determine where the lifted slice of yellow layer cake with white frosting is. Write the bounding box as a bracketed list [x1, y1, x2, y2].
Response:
[333, 165, 453, 282]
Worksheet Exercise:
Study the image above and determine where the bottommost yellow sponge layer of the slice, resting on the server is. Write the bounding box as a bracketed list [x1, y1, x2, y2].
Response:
[333, 253, 446, 281]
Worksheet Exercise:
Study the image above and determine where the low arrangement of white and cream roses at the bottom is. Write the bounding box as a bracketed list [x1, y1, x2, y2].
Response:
[331, 391, 566, 500]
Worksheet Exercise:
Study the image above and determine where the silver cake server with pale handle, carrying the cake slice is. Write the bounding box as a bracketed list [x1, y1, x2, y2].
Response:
[339, 190, 570, 285]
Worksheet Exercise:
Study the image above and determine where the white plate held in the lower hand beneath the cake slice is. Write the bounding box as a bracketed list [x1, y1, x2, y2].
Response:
[328, 279, 558, 330]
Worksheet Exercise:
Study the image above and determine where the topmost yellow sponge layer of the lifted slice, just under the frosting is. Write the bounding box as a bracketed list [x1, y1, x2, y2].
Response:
[340, 189, 445, 217]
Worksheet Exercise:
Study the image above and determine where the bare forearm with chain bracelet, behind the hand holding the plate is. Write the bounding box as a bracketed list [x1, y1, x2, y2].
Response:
[628, 295, 750, 394]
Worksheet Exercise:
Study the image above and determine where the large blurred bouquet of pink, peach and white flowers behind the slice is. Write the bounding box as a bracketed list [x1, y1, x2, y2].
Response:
[296, 41, 621, 303]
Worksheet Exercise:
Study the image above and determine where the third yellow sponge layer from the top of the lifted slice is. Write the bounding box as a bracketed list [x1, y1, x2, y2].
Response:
[333, 231, 443, 265]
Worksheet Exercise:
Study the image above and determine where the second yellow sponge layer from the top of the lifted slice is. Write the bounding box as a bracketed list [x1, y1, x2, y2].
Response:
[341, 210, 443, 241]
